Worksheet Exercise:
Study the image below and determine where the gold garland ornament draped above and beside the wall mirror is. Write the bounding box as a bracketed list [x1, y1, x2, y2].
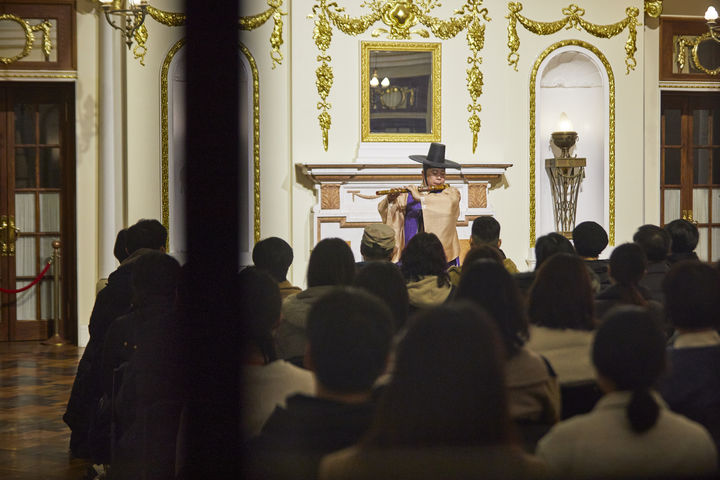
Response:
[308, 0, 490, 152]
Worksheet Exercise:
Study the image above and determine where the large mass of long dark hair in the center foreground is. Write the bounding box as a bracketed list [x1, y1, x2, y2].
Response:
[360, 303, 512, 448]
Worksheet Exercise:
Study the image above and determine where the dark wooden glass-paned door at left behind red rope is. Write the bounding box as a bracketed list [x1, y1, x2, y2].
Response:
[0, 83, 75, 341]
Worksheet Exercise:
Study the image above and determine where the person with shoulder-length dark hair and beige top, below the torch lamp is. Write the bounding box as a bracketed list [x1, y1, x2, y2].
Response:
[527, 253, 595, 385]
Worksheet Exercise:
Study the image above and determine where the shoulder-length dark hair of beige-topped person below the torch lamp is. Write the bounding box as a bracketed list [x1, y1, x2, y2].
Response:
[528, 253, 595, 330]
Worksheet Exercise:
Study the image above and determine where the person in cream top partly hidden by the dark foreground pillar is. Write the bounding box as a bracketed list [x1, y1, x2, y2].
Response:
[238, 267, 314, 438]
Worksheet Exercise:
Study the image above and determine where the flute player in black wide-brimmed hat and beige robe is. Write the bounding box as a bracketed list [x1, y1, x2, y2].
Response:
[378, 143, 460, 265]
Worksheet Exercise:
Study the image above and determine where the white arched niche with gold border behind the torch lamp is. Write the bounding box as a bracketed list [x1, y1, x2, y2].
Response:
[530, 40, 615, 258]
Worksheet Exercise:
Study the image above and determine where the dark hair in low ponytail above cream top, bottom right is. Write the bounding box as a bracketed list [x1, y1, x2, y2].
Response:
[592, 306, 666, 433]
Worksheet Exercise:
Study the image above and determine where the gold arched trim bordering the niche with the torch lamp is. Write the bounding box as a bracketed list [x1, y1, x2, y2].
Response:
[529, 40, 615, 247]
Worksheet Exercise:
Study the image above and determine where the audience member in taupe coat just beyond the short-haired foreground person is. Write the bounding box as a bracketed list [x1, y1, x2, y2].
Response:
[277, 238, 355, 366]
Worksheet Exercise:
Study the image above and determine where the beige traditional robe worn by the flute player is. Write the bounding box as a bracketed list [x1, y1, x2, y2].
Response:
[378, 187, 460, 262]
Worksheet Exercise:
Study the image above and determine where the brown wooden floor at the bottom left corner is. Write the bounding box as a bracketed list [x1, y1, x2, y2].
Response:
[0, 342, 87, 480]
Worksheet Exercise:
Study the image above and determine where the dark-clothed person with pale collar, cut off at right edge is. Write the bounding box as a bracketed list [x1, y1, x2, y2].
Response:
[660, 261, 720, 450]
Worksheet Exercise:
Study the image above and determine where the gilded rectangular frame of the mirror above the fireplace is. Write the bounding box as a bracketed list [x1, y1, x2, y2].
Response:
[360, 42, 442, 142]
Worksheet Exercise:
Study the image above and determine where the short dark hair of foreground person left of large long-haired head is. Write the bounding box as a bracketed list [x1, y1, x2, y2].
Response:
[307, 287, 393, 393]
